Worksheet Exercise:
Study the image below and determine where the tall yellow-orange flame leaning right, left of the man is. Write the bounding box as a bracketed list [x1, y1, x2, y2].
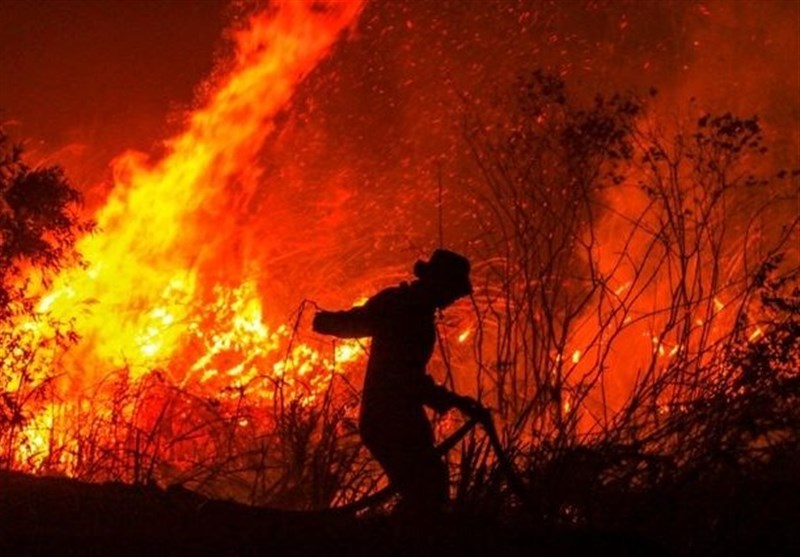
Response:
[12, 0, 363, 473]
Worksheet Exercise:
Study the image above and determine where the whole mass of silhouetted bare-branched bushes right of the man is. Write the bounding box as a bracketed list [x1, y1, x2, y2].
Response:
[459, 72, 800, 553]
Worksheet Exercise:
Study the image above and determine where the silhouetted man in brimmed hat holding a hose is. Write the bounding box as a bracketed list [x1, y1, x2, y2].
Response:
[313, 249, 477, 515]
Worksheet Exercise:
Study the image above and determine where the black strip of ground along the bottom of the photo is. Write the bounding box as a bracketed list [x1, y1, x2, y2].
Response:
[0, 466, 800, 557]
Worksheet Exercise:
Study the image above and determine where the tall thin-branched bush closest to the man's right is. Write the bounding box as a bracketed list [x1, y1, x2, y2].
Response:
[463, 71, 642, 438]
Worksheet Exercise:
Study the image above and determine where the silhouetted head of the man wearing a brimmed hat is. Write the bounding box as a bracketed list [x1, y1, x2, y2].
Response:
[414, 249, 472, 308]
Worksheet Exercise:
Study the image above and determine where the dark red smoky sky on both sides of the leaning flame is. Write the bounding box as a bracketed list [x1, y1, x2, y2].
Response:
[0, 0, 800, 300]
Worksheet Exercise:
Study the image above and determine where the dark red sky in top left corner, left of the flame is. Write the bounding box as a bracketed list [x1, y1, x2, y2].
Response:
[0, 0, 226, 177]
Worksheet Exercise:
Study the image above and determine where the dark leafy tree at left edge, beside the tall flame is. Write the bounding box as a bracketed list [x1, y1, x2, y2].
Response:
[0, 127, 92, 466]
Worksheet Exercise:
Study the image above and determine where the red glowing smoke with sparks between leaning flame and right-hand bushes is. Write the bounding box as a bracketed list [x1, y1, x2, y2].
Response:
[216, 0, 800, 303]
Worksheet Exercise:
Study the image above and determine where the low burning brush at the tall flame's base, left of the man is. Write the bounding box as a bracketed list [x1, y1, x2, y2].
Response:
[9, 292, 364, 474]
